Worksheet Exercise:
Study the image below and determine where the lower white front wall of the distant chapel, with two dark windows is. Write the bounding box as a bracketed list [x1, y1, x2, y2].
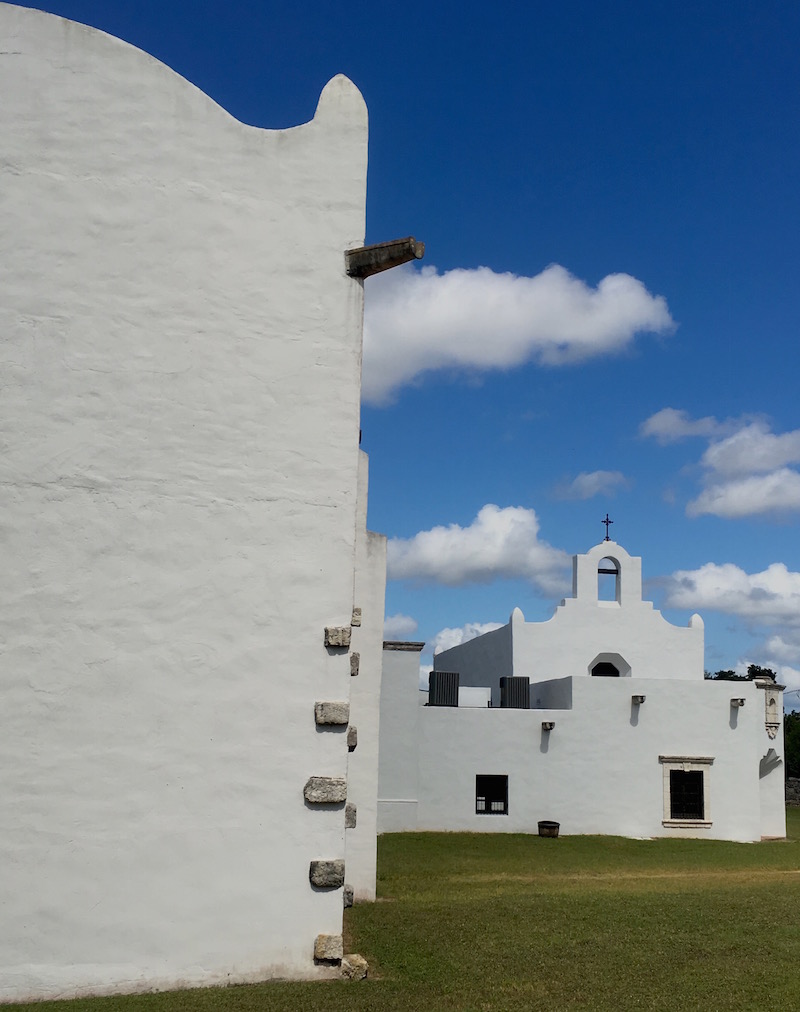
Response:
[417, 678, 785, 841]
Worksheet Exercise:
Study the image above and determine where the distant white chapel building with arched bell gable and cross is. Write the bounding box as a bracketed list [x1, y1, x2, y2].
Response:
[378, 540, 786, 841]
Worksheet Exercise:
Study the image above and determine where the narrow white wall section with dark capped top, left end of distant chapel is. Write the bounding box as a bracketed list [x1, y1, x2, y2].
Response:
[378, 643, 427, 833]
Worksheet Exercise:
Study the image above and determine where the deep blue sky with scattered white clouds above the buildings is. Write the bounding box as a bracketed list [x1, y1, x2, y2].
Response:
[21, 0, 800, 700]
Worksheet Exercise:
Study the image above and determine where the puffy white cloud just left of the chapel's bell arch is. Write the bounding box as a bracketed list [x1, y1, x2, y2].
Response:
[387, 503, 569, 594]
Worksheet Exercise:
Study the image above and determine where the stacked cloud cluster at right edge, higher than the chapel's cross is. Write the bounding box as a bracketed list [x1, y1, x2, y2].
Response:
[639, 408, 800, 519]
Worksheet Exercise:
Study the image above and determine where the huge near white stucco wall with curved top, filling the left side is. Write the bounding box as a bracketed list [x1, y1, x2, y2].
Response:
[0, 4, 367, 1000]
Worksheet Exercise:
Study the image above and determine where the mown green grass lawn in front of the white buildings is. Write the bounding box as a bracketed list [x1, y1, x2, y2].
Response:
[6, 809, 800, 1012]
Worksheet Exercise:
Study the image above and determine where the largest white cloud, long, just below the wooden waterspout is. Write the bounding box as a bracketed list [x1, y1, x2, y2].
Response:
[362, 264, 675, 404]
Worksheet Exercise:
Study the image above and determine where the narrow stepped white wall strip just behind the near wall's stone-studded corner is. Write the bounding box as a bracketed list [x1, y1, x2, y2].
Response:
[345, 452, 386, 902]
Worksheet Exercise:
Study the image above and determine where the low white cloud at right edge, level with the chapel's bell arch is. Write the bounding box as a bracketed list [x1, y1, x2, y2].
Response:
[664, 563, 800, 625]
